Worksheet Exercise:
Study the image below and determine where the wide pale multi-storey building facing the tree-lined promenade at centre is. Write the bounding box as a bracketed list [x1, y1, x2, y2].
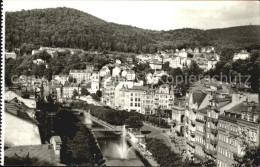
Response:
[115, 84, 174, 114]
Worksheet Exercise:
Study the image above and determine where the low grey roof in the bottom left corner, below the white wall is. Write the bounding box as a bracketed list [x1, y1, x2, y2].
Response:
[4, 144, 56, 166]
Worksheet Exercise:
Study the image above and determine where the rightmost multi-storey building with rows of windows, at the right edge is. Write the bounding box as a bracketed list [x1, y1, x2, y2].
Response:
[217, 95, 260, 167]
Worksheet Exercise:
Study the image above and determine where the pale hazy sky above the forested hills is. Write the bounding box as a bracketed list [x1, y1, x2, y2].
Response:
[4, 0, 260, 30]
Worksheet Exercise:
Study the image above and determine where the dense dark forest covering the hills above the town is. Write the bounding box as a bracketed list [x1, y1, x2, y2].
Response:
[5, 8, 260, 53]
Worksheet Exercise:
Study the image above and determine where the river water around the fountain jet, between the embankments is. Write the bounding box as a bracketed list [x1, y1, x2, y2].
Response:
[88, 122, 144, 166]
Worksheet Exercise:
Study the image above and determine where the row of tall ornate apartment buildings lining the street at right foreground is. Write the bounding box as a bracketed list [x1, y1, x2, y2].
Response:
[170, 81, 260, 167]
